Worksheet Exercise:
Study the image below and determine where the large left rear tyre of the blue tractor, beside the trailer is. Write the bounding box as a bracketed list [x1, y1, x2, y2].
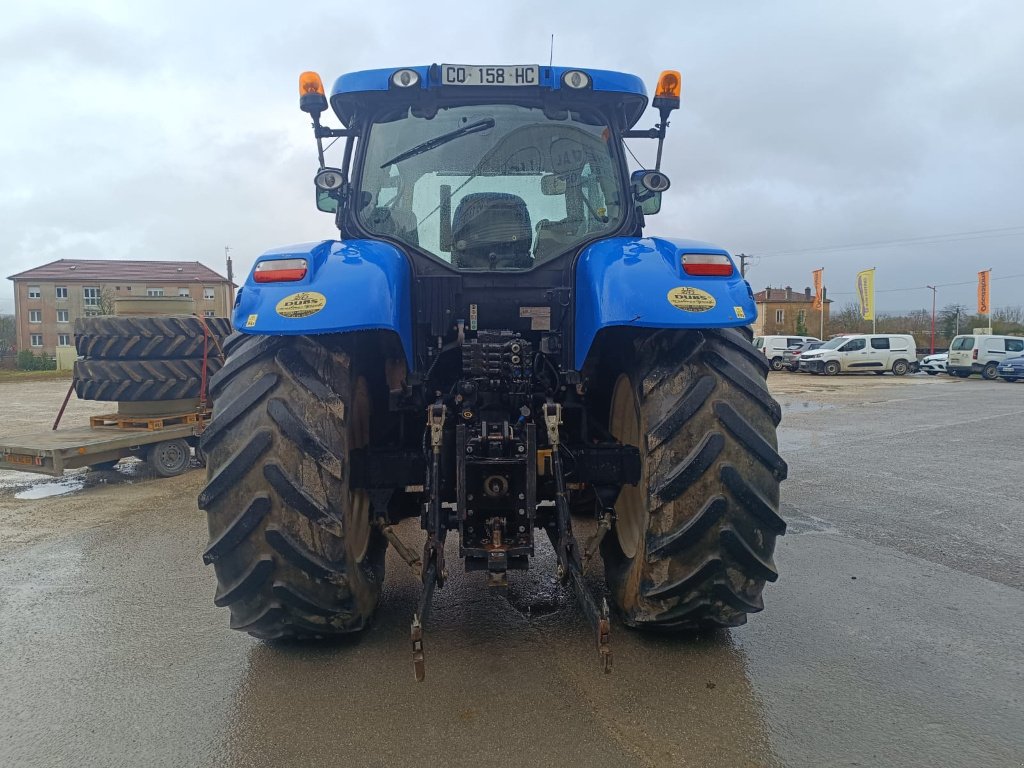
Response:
[199, 336, 386, 640]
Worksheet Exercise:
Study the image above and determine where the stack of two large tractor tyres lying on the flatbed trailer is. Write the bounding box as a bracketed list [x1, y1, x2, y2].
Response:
[75, 314, 230, 402]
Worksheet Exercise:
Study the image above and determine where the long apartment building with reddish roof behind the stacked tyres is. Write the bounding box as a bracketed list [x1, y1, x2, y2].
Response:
[7, 259, 234, 354]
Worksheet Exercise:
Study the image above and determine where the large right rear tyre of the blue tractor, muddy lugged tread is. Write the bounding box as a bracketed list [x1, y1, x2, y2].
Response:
[602, 329, 787, 632]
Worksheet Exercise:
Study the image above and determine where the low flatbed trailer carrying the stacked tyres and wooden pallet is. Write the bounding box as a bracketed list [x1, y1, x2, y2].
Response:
[0, 411, 210, 477]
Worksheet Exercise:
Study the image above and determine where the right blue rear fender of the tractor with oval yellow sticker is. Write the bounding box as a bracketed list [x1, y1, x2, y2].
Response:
[574, 238, 757, 370]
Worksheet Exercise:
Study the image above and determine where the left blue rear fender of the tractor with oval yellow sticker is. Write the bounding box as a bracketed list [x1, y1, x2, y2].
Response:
[232, 240, 414, 370]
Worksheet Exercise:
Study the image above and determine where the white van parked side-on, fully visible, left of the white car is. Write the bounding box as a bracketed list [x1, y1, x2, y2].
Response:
[800, 334, 918, 376]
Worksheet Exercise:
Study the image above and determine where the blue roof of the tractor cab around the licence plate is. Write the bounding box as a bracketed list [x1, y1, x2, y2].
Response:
[331, 63, 647, 127]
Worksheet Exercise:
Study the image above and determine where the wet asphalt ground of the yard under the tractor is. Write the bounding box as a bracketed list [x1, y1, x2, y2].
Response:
[0, 374, 1024, 768]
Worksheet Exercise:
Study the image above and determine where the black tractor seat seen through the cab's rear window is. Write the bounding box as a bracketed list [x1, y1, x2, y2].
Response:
[452, 193, 534, 269]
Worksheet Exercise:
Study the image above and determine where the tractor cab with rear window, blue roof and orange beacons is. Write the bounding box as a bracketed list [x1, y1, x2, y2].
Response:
[302, 65, 679, 272]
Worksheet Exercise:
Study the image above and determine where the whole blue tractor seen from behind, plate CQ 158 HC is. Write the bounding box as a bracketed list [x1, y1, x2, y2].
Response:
[200, 65, 786, 679]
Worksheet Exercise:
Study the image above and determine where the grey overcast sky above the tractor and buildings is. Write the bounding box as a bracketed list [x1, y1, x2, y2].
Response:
[0, 0, 1024, 311]
